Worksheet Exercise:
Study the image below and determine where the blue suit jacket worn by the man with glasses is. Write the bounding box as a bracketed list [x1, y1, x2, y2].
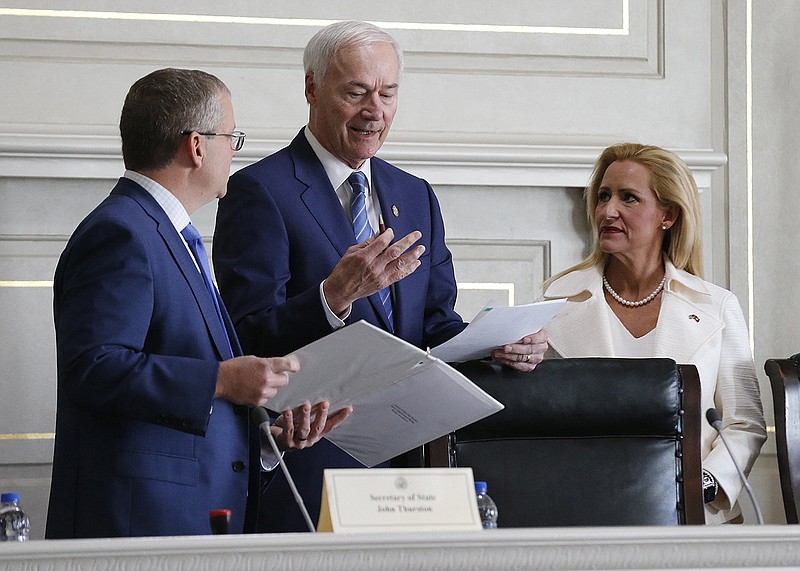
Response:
[46, 179, 257, 538]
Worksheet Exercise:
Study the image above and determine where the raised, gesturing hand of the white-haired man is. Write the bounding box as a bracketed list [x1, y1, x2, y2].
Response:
[322, 228, 425, 315]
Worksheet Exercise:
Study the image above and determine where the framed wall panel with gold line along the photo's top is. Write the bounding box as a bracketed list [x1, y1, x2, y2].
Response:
[0, 0, 664, 77]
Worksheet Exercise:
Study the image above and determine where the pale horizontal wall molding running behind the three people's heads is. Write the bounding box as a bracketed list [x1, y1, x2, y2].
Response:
[0, 131, 726, 189]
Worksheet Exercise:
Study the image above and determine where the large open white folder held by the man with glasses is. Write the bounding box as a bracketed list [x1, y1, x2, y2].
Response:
[267, 321, 503, 467]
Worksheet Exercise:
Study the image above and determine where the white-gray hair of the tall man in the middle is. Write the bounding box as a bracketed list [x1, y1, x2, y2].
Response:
[303, 20, 403, 85]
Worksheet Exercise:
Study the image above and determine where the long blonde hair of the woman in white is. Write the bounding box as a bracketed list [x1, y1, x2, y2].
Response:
[544, 143, 703, 290]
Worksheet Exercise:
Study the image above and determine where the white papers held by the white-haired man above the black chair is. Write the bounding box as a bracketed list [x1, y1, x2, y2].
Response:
[431, 299, 567, 363]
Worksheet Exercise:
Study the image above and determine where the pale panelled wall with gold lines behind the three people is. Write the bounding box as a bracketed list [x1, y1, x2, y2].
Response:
[0, 0, 788, 536]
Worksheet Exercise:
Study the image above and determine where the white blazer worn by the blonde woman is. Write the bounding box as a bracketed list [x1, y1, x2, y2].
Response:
[544, 259, 767, 523]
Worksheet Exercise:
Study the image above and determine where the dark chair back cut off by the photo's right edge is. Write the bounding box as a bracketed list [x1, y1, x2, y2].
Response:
[764, 355, 800, 523]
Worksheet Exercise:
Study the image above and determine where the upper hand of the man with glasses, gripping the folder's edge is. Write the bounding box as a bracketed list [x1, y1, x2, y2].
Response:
[214, 355, 300, 406]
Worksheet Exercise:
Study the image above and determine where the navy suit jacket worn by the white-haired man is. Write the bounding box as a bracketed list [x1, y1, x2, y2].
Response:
[214, 131, 465, 531]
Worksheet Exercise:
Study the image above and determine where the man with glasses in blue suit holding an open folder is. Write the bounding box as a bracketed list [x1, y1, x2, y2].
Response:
[46, 69, 348, 538]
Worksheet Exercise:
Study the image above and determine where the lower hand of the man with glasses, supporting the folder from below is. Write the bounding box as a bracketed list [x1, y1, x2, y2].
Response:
[270, 401, 353, 451]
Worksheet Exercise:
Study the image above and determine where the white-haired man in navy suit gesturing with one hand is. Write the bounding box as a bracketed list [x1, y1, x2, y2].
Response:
[214, 22, 547, 531]
